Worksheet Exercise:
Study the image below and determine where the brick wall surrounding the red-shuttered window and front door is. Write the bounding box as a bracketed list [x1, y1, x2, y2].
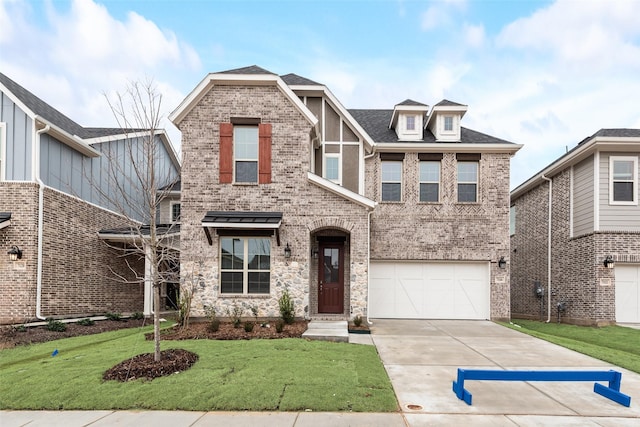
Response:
[180, 86, 367, 318]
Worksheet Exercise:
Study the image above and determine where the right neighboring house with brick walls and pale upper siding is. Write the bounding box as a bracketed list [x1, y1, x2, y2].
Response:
[511, 129, 640, 325]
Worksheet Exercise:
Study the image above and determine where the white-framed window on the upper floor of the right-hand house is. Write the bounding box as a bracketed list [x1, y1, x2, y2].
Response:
[609, 156, 638, 205]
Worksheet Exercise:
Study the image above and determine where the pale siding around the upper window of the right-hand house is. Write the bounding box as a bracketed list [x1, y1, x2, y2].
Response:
[598, 153, 640, 231]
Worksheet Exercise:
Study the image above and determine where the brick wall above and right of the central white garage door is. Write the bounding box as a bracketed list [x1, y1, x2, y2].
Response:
[366, 153, 510, 320]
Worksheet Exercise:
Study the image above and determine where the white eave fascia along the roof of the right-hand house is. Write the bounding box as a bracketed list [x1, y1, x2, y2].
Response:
[511, 136, 640, 200]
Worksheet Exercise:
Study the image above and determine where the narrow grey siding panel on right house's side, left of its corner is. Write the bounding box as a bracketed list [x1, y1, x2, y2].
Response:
[572, 156, 594, 236]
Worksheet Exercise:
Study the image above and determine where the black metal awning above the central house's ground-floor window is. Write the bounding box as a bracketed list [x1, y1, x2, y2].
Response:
[202, 211, 282, 246]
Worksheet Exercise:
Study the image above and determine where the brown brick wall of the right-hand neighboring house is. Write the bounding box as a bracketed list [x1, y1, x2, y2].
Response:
[511, 171, 640, 325]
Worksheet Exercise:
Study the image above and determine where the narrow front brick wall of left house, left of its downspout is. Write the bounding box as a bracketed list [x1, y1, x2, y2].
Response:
[0, 182, 38, 324]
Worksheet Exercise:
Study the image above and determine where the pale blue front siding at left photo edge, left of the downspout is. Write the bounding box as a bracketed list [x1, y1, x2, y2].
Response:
[0, 92, 33, 181]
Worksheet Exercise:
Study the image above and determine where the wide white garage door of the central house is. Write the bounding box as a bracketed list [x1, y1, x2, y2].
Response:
[369, 262, 490, 319]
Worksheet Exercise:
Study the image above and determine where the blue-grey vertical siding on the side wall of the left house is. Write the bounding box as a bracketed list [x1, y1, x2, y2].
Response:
[40, 135, 178, 221]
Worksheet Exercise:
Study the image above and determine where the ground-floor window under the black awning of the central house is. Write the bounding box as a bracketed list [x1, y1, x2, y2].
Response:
[220, 237, 271, 295]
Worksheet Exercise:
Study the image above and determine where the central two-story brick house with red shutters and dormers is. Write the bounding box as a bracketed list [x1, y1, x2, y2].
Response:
[170, 66, 521, 319]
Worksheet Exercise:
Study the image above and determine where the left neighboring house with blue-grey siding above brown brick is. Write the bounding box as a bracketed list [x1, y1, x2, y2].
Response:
[0, 73, 180, 324]
